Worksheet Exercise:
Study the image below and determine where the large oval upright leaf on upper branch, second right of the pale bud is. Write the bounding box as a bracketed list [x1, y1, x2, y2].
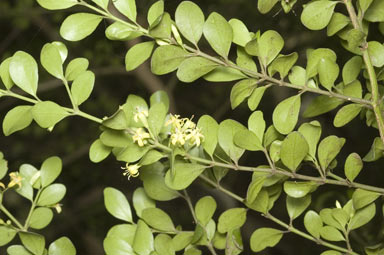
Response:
[203, 12, 233, 58]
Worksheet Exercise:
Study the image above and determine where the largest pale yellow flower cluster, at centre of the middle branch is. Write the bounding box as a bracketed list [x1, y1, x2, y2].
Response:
[165, 114, 204, 146]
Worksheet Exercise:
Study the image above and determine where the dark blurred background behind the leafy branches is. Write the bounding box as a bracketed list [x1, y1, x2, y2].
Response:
[0, 0, 384, 255]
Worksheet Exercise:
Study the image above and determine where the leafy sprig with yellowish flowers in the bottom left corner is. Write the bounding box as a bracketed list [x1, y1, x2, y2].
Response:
[0, 153, 76, 255]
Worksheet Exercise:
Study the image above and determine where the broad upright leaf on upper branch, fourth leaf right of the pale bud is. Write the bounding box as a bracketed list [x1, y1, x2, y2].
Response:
[257, 30, 284, 67]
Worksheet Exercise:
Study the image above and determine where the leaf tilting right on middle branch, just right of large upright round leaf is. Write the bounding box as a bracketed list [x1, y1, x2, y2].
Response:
[317, 135, 345, 172]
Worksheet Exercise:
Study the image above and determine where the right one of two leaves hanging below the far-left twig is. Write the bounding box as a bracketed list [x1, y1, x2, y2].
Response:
[32, 101, 69, 128]
